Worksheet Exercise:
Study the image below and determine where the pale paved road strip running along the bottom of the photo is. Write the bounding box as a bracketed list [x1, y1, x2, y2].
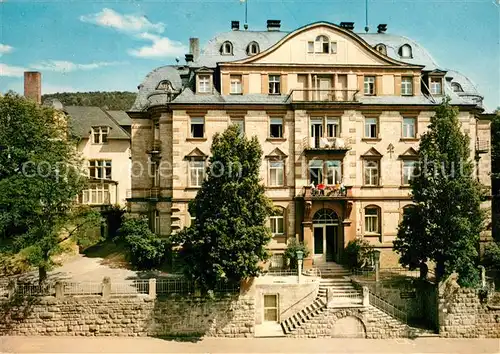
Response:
[0, 337, 500, 354]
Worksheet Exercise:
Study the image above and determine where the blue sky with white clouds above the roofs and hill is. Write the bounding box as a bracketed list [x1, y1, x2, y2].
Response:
[0, 0, 500, 110]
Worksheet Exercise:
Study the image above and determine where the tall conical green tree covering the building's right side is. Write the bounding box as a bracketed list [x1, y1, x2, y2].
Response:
[394, 99, 484, 286]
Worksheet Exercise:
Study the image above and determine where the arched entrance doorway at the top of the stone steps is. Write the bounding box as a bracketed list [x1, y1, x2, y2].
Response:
[312, 209, 340, 264]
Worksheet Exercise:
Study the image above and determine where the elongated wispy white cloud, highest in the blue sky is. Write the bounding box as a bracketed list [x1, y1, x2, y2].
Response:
[80, 8, 165, 33]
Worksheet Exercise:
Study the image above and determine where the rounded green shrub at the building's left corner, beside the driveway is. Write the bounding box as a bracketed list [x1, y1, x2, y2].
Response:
[118, 218, 170, 269]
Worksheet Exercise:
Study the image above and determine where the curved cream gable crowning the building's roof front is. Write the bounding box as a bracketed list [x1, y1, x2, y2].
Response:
[235, 23, 418, 66]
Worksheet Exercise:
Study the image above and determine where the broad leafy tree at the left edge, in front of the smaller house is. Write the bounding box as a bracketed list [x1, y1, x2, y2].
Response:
[0, 93, 92, 282]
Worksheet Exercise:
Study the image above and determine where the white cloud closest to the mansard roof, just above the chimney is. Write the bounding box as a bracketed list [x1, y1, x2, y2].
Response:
[128, 33, 187, 58]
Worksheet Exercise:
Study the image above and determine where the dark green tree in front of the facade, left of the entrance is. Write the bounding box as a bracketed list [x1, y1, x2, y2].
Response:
[173, 125, 273, 291]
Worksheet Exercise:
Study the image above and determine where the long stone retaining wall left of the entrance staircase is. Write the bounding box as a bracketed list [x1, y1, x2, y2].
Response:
[0, 296, 255, 337]
